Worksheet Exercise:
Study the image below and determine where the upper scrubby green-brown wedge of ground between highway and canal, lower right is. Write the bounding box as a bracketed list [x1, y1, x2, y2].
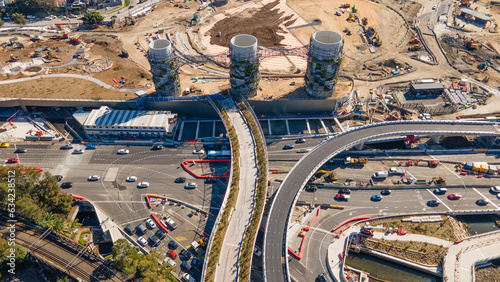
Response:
[370, 216, 457, 242]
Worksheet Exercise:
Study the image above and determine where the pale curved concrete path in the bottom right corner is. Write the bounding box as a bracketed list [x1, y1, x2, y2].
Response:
[443, 231, 500, 282]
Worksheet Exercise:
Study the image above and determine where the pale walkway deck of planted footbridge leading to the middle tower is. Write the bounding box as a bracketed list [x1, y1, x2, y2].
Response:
[215, 99, 258, 281]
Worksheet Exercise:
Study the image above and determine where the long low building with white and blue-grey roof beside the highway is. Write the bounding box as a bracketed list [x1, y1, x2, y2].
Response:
[73, 106, 177, 138]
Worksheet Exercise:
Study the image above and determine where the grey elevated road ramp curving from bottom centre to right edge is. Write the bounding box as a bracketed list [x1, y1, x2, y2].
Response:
[262, 120, 500, 281]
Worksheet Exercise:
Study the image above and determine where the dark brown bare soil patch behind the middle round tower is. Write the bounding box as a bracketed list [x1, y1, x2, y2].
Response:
[209, 1, 295, 47]
